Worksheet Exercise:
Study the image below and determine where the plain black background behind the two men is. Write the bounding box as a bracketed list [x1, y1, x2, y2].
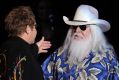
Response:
[0, 0, 119, 61]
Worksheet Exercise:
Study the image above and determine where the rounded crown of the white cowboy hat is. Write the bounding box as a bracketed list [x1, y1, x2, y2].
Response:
[74, 5, 98, 21]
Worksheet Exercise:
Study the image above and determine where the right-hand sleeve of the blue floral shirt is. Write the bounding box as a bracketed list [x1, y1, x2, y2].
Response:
[85, 49, 119, 80]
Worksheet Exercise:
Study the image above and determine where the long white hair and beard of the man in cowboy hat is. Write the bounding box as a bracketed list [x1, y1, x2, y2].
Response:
[63, 25, 110, 62]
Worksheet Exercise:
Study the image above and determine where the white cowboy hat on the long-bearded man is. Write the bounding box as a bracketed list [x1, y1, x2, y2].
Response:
[63, 5, 110, 32]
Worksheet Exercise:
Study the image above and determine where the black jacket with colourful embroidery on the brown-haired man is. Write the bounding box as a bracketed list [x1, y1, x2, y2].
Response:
[2, 37, 43, 80]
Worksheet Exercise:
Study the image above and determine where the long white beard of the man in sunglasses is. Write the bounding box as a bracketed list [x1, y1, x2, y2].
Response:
[68, 37, 92, 64]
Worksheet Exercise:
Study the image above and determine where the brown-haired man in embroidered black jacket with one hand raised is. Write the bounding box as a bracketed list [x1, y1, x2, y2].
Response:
[0, 6, 51, 80]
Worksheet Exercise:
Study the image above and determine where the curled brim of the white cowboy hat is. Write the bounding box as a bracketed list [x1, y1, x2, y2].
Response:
[63, 16, 110, 32]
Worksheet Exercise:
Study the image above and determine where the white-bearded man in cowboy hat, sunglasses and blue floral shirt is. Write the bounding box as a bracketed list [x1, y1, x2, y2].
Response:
[42, 5, 119, 80]
